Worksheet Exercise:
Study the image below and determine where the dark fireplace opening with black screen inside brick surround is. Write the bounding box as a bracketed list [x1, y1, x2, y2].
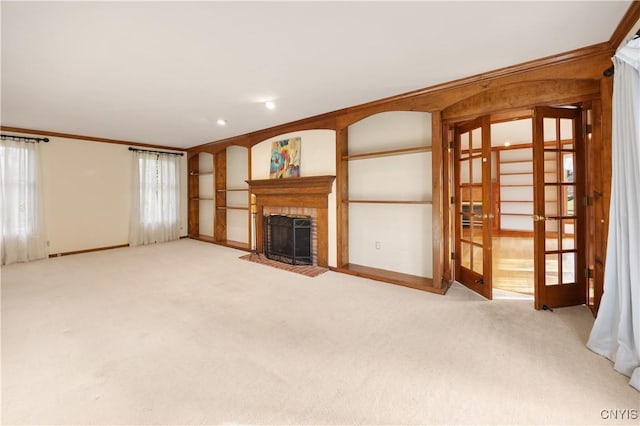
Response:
[263, 214, 313, 265]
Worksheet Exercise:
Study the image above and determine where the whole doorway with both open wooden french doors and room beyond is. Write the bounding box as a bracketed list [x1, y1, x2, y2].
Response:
[453, 107, 586, 309]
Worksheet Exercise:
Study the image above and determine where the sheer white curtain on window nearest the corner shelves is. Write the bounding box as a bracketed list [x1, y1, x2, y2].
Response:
[129, 151, 180, 246]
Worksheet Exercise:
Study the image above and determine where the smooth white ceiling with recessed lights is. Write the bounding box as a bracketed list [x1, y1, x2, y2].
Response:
[1, 1, 630, 147]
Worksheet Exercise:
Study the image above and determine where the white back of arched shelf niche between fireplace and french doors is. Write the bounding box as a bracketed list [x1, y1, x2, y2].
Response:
[349, 112, 433, 277]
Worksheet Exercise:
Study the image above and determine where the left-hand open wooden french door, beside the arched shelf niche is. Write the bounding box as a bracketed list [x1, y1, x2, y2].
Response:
[454, 116, 493, 299]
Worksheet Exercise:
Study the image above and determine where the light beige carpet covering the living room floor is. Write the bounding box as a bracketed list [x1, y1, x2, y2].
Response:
[2, 240, 640, 424]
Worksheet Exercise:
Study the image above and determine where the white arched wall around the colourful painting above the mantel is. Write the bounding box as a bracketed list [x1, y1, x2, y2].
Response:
[251, 130, 338, 267]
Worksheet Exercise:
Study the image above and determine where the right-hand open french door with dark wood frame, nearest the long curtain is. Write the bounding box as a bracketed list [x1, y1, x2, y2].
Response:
[533, 107, 586, 309]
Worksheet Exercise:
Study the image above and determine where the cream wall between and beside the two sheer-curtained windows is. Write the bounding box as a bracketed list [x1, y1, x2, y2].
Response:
[32, 132, 188, 254]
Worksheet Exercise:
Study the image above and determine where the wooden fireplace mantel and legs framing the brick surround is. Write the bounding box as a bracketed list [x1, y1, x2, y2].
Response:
[246, 176, 336, 268]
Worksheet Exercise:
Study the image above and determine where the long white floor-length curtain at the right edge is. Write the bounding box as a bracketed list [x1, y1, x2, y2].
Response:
[587, 38, 640, 390]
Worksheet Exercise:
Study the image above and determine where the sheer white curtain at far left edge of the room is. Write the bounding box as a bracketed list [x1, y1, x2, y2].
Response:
[0, 140, 48, 265]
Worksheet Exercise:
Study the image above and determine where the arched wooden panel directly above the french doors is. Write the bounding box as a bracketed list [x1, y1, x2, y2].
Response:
[442, 80, 600, 120]
